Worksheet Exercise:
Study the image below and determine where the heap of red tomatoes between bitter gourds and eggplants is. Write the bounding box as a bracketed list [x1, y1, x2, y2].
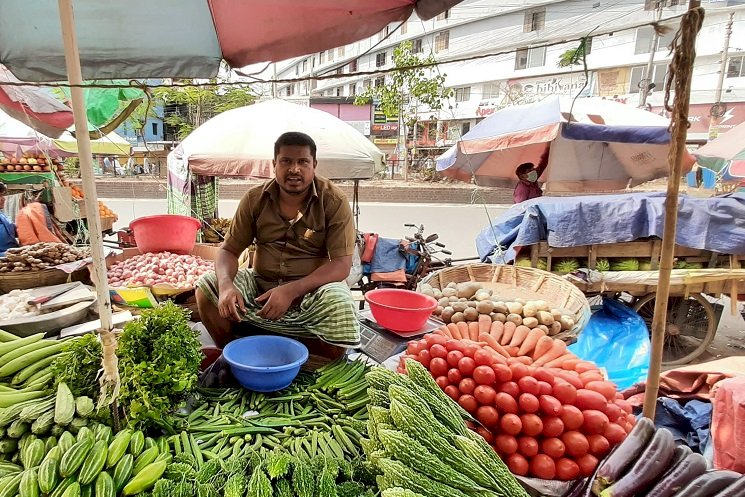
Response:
[399, 333, 635, 480]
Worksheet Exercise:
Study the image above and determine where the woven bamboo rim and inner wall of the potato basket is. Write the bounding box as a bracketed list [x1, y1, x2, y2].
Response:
[422, 263, 591, 340]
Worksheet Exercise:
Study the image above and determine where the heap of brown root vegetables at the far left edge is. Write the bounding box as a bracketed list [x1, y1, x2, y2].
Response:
[0, 242, 90, 273]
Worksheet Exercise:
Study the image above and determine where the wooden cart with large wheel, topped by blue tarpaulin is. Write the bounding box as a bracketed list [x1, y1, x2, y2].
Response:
[476, 193, 745, 365]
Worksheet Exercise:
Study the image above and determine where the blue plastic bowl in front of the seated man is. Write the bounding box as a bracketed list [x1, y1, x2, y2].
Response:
[222, 335, 308, 392]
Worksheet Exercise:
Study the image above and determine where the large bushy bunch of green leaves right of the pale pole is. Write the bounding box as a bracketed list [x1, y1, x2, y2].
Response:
[117, 301, 202, 427]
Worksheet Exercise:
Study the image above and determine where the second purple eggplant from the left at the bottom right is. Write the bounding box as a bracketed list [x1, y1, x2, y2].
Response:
[600, 428, 675, 497]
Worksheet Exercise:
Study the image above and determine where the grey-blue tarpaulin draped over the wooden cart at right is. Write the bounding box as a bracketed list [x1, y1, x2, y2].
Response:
[476, 193, 745, 263]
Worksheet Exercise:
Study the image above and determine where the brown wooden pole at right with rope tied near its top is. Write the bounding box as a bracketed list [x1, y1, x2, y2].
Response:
[643, 0, 704, 420]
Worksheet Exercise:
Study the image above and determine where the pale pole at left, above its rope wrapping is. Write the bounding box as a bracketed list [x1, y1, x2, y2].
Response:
[58, 0, 113, 331]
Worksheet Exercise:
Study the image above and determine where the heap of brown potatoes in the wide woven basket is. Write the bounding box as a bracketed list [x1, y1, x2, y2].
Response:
[419, 282, 575, 336]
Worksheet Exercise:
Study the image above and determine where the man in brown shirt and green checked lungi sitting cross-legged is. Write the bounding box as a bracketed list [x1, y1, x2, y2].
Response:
[197, 132, 360, 347]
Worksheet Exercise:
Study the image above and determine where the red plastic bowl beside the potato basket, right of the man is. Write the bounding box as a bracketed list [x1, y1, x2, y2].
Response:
[365, 288, 437, 332]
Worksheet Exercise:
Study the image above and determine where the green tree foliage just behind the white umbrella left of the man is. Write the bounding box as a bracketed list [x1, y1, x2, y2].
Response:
[153, 79, 256, 140]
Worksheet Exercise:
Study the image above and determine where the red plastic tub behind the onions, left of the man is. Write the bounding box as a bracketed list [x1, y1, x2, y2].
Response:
[129, 214, 201, 254]
